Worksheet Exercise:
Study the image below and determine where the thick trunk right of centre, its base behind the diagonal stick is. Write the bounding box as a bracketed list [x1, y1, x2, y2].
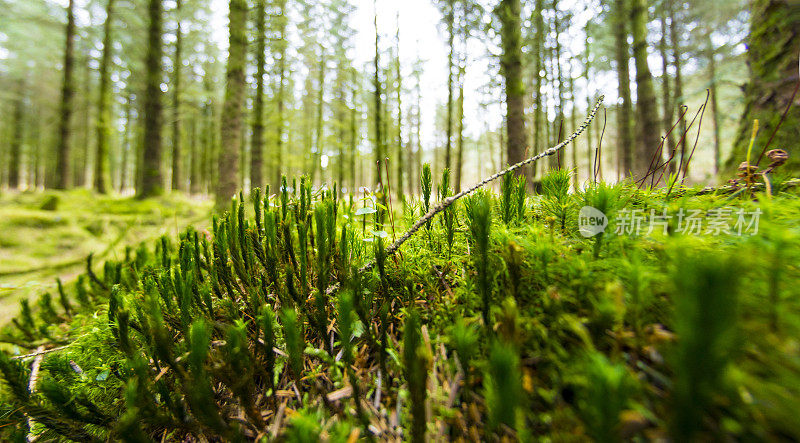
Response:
[496, 0, 527, 175]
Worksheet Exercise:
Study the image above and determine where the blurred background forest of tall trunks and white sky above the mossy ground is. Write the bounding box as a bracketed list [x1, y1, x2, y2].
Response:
[0, 0, 800, 206]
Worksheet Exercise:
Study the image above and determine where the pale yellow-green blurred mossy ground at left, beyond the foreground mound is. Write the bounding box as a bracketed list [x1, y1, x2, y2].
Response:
[0, 190, 211, 325]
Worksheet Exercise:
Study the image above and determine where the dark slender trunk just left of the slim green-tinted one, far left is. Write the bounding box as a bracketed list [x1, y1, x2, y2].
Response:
[55, 0, 75, 189]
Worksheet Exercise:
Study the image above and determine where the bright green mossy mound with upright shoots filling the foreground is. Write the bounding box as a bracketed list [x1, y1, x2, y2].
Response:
[0, 167, 800, 442]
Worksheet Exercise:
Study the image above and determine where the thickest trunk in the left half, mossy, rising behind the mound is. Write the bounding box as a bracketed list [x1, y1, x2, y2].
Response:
[215, 0, 247, 211]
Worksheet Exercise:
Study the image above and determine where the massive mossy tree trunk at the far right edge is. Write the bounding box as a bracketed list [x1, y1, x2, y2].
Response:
[725, 0, 800, 173]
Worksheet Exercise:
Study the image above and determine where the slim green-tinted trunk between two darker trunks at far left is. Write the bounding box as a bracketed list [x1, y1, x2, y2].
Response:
[94, 0, 114, 194]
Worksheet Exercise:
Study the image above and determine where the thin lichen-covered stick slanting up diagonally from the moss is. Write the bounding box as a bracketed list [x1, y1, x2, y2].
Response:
[326, 95, 604, 295]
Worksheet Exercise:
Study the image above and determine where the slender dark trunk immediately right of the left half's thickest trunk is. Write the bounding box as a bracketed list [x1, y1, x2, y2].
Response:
[250, 0, 267, 188]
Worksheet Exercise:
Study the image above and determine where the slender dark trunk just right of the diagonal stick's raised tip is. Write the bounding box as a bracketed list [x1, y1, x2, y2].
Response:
[614, 0, 633, 177]
